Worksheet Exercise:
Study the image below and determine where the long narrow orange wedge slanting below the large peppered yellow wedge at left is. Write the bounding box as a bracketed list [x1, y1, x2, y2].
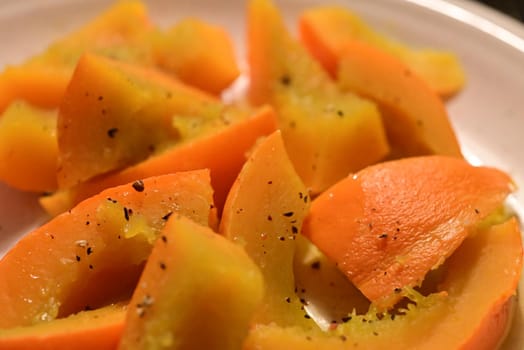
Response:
[40, 106, 276, 216]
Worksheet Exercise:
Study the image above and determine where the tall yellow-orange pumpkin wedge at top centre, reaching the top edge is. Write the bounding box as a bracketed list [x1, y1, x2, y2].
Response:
[248, 0, 389, 193]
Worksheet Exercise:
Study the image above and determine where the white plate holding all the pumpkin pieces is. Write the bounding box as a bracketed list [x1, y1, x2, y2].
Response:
[0, 0, 524, 349]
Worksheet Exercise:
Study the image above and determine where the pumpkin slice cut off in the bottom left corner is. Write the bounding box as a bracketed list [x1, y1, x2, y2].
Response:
[0, 305, 126, 350]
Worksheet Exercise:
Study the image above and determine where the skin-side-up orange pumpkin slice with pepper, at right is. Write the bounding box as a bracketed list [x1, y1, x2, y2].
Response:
[303, 156, 513, 308]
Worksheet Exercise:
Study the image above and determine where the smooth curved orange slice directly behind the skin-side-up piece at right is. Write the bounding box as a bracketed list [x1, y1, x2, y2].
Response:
[338, 40, 462, 157]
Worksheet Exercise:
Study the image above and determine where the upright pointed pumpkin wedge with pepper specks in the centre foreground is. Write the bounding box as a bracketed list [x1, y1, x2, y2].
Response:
[220, 131, 315, 328]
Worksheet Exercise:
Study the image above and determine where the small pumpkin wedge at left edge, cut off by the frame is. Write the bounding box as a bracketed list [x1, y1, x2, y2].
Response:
[0, 101, 58, 192]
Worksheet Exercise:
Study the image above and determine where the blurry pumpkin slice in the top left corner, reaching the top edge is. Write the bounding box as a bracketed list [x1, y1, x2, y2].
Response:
[0, 1, 152, 111]
